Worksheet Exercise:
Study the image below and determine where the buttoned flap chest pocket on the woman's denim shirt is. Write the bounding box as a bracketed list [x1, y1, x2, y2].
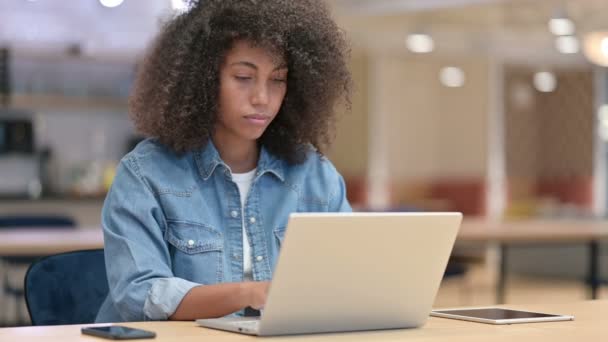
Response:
[165, 221, 224, 285]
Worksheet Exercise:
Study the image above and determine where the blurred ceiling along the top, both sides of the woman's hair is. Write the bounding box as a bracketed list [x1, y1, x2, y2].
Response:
[0, 0, 608, 63]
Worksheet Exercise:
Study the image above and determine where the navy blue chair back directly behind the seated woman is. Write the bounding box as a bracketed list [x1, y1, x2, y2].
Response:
[24, 249, 109, 325]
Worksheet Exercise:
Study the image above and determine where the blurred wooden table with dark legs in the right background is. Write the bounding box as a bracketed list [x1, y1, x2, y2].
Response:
[457, 219, 608, 303]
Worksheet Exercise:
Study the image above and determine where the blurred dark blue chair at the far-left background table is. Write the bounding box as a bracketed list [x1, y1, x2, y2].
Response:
[0, 215, 76, 325]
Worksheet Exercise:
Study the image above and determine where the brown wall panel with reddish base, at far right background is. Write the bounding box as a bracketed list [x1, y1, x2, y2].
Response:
[504, 66, 594, 215]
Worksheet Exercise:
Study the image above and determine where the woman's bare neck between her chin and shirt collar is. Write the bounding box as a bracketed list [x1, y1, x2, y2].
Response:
[213, 135, 260, 173]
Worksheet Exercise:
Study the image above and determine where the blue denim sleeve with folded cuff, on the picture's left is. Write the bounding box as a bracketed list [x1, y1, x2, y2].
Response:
[102, 156, 200, 321]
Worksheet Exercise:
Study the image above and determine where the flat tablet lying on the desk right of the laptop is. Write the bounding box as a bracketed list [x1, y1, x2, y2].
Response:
[431, 307, 574, 324]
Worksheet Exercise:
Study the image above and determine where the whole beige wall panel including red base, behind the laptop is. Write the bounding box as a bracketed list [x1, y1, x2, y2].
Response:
[370, 55, 489, 214]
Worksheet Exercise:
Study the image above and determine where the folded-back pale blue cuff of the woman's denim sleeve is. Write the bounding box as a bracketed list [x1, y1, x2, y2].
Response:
[144, 278, 200, 321]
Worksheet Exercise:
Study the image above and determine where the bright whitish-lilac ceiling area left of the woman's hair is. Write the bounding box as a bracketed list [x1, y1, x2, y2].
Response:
[0, 0, 172, 60]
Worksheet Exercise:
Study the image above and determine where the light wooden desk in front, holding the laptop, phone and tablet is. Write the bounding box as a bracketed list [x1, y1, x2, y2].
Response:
[0, 301, 608, 342]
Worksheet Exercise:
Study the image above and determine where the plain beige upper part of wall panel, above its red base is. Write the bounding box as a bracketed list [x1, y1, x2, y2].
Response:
[378, 56, 488, 181]
